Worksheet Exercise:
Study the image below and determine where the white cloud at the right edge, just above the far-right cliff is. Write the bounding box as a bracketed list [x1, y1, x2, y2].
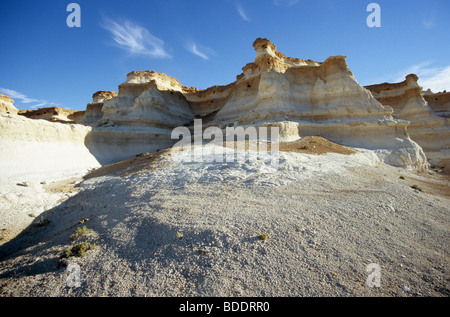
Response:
[396, 61, 450, 92]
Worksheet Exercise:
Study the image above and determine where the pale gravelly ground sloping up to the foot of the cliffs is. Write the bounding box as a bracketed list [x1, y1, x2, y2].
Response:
[0, 140, 450, 297]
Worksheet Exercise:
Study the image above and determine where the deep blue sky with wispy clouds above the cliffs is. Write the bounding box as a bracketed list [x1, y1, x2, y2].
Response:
[0, 0, 450, 110]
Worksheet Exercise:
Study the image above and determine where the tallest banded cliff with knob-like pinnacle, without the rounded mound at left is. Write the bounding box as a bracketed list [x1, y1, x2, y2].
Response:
[195, 39, 425, 168]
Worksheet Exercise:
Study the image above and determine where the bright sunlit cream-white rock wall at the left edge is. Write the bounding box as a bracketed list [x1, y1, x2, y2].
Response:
[0, 111, 100, 180]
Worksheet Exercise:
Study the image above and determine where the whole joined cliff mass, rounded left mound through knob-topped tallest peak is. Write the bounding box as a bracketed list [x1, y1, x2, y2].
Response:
[82, 39, 426, 169]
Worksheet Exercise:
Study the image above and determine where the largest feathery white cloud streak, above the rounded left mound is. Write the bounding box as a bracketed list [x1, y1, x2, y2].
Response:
[100, 18, 171, 58]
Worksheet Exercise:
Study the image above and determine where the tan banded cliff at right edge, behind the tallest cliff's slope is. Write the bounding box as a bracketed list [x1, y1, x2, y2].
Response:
[366, 74, 450, 162]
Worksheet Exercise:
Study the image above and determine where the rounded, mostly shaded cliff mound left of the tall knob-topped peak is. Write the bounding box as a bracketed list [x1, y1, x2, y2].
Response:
[82, 71, 189, 164]
